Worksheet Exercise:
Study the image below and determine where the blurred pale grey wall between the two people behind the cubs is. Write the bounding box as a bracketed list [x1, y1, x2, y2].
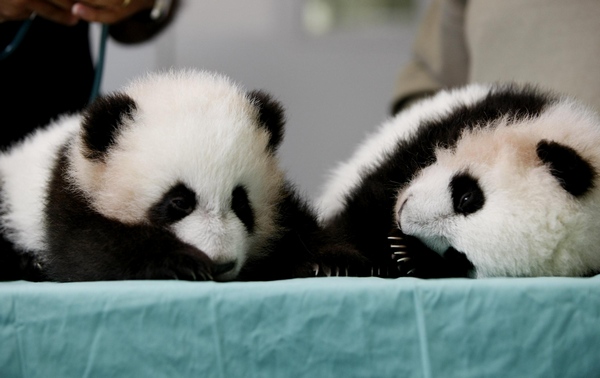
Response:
[97, 0, 427, 199]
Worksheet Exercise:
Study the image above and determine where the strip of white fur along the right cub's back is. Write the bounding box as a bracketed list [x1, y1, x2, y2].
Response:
[317, 85, 488, 222]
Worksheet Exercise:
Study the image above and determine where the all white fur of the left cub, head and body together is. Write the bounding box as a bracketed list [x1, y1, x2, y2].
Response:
[0, 70, 283, 279]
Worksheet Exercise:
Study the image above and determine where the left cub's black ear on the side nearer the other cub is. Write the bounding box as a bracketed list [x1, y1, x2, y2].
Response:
[248, 91, 285, 151]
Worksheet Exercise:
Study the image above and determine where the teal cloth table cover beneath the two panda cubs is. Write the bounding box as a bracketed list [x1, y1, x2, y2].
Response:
[0, 276, 600, 378]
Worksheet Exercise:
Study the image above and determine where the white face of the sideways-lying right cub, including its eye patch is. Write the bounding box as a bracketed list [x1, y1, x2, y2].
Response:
[395, 110, 600, 277]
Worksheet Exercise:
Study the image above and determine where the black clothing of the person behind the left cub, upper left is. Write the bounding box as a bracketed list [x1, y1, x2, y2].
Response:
[0, 18, 94, 149]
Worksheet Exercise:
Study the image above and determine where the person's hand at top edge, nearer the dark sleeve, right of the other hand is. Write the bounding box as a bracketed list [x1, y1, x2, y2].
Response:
[72, 0, 154, 24]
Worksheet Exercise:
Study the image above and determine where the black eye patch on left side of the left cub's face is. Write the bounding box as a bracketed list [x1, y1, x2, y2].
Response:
[149, 183, 196, 225]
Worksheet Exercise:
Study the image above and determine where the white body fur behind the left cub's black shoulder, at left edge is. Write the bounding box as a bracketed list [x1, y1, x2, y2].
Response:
[0, 116, 79, 254]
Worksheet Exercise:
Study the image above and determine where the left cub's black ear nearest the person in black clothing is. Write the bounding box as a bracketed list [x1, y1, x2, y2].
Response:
[82, 93, 137, 161]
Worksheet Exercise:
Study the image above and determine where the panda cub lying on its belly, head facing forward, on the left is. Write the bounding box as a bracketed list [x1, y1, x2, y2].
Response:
[0, 70, 346, 281]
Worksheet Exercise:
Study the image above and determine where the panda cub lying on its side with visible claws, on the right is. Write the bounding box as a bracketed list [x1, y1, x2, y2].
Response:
[320, 84, 600, 278]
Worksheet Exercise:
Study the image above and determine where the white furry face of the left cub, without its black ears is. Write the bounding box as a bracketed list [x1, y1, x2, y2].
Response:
[68, 73, 283, 280]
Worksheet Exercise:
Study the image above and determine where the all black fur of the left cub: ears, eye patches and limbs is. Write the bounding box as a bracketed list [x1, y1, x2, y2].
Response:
[0, 74, 350, 281]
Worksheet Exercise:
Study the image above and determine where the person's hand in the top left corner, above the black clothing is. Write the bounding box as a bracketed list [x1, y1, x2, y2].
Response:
[0, 0, 78, 25]
